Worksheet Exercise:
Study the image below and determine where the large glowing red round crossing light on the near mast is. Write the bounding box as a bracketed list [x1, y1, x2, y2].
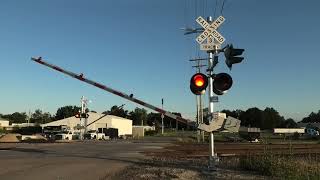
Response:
[190, 73, 208, 95]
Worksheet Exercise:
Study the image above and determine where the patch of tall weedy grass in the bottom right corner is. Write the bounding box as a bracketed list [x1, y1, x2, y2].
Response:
[239, 153, 320, 179]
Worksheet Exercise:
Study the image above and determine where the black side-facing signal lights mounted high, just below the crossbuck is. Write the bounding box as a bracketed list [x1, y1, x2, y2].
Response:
[224, 44, 244, 70]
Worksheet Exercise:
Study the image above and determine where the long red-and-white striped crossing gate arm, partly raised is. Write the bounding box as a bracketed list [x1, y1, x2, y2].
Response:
[31, 57, 190, 124]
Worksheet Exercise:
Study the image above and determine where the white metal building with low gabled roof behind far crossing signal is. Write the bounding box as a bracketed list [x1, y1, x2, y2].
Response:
[41, 112, 132, 136]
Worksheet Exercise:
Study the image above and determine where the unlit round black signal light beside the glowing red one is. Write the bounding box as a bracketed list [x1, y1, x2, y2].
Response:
[212, 73, 233, 95]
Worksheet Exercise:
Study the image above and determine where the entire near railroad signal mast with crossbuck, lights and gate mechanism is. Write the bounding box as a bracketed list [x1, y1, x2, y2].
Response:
[185, 16, 244, 169]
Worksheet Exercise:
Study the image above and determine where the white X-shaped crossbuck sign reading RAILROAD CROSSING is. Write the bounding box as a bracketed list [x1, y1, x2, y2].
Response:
[196, 16, 225, 45]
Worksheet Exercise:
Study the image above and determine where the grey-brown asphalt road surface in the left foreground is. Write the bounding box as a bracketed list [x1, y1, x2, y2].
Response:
[0, 141, 168, 180]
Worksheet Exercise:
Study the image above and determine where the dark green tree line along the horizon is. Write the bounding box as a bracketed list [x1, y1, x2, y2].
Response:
[0, 105, 320, 129]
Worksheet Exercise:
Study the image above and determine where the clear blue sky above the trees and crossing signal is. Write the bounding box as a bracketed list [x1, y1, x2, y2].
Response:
[0, 0, 320, 120]
